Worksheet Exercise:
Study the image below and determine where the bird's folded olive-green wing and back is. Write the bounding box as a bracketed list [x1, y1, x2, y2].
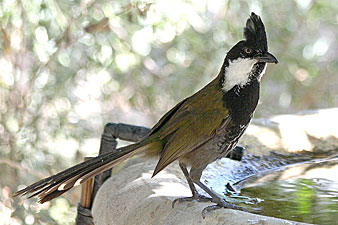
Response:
[153, 79, 229, 176]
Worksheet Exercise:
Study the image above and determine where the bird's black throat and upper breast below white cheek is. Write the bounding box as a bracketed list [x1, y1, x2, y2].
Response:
[221, 63, 265, 125]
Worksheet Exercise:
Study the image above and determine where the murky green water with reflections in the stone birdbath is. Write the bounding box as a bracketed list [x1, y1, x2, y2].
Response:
[241, 179, 338, 225]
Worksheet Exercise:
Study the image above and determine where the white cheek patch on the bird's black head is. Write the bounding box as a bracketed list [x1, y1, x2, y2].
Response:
[222, 58, 257, 92]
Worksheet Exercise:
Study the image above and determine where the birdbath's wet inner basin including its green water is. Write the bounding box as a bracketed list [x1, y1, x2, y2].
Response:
[202, 150, 338, 225]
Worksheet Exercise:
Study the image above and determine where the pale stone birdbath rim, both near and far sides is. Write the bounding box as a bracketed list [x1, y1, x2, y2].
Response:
[92, 108, 338, 225]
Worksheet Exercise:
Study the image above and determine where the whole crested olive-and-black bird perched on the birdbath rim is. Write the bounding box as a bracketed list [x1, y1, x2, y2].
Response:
[14, 12, 278, 214]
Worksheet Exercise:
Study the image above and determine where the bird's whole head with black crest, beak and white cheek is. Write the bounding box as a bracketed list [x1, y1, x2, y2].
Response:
[221, 13, 278, 92]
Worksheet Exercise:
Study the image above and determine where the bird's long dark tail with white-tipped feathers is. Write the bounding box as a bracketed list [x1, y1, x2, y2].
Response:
[13, 142, 149, 203]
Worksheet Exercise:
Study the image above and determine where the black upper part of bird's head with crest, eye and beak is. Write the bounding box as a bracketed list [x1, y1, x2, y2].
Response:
[226, 12, 278, 63]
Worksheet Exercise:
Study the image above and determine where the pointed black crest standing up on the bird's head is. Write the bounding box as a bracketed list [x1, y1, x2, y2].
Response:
[244, 12, 268, 51]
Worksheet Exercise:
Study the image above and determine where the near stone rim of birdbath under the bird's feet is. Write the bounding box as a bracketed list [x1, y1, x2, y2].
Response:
[92, 159, 308, 225]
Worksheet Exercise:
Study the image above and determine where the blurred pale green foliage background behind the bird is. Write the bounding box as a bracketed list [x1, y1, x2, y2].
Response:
[0, 0, 338, 224]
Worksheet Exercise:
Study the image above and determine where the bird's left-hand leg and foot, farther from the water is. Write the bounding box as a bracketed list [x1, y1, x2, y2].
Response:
[172, 162, 211, 208]
